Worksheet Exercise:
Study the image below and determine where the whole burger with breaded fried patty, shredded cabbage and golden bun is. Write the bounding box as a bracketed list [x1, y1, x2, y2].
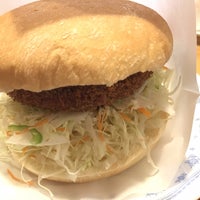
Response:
[0, 0, 173, 182]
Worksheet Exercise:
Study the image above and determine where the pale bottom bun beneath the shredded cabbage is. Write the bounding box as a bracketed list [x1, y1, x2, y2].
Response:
[11, 117, 168, 183]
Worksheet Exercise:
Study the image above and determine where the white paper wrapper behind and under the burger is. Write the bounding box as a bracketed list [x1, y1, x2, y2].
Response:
[0, 0, 198, 200]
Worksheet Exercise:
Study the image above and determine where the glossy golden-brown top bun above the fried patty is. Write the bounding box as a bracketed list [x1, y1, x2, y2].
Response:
[0, 0, 173, 92]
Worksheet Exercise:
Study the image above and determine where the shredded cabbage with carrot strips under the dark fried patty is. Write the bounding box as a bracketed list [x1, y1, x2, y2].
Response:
[0, 68, 178, 181]
